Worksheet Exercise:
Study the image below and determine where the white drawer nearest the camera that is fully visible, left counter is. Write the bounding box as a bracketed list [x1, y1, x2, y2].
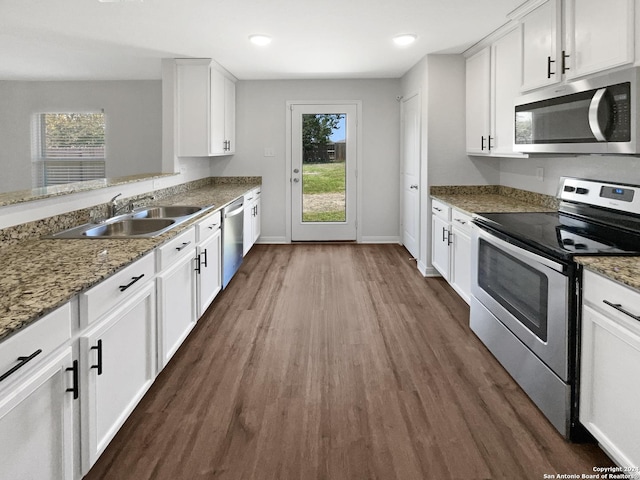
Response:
[80, 253, 155, 328]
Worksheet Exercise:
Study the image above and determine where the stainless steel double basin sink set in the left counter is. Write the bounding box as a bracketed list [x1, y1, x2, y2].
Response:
[49, 205, 214, 239]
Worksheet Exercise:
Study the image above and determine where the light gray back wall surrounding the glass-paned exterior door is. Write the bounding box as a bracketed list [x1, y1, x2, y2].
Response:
[211, 79, 400, 241]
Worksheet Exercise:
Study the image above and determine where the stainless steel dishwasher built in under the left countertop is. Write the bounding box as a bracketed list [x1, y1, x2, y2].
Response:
[222, 197, 244, 288]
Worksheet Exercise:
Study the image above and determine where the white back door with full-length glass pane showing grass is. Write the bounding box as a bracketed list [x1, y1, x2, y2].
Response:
[291, 104, 358, 241]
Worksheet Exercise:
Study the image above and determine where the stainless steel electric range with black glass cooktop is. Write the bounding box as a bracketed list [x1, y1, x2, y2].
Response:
[471, 177, 640, 440]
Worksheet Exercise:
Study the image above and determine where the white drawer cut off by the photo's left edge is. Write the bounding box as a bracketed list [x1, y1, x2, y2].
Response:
[0, 303, 72, 389]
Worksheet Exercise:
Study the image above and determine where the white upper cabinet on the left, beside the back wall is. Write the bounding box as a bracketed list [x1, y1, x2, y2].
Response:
[176, 58, 236, 157]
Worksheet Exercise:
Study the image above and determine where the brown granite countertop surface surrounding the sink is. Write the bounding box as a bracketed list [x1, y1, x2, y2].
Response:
[0, 183, 260, 341]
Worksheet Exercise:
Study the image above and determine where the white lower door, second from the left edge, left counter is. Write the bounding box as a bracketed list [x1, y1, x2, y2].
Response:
[80, 283, 156, 473]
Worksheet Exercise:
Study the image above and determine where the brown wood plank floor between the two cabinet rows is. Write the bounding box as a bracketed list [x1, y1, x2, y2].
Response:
[86, 244, 613, 480]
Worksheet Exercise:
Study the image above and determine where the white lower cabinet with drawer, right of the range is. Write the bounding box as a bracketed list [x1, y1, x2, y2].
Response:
[579, 271, 640, 468]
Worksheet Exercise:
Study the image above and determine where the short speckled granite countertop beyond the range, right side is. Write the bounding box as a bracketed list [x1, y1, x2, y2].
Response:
[430, 185, 558, 215]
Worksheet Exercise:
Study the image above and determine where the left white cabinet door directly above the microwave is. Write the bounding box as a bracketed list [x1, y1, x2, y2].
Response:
[521, 0, 562, 90]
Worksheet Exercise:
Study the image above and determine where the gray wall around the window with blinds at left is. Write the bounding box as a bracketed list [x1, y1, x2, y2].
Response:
[0, 80, 162, 192]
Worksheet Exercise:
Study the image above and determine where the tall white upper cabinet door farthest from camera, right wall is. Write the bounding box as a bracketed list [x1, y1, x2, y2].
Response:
[466, 47, 491, 155]
